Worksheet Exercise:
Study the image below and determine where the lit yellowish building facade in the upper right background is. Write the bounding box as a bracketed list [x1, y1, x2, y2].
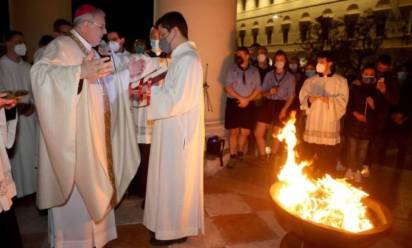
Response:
[236, 0, 412, 52]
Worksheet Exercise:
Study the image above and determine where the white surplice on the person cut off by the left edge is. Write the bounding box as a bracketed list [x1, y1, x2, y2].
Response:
[0, 108, 17, 213]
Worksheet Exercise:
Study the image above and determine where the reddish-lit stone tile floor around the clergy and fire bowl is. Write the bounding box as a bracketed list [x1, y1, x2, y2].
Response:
[16, 154, 412, 248]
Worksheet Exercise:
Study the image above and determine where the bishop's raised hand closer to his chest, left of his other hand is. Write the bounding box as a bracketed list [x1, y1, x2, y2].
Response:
[80, 51, 113, 82]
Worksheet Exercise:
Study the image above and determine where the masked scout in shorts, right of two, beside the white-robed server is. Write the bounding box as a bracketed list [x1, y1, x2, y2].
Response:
[255, 50, 296, 163]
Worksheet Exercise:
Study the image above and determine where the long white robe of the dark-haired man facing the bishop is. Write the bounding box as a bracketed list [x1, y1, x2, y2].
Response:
[143, 42, 205, 240]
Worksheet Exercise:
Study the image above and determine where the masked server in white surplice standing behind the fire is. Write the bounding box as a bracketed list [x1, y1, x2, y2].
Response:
[299, 52, 349, 174]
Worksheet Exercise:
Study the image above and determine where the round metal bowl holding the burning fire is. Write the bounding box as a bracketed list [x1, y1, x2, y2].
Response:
[270, 182, 393, 248]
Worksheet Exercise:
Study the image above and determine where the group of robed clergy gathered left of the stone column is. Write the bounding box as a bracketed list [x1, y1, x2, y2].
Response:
[0, 4, 205, 248]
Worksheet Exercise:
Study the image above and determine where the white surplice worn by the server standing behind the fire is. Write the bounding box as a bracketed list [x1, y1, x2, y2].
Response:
[299, 73, 349, 145]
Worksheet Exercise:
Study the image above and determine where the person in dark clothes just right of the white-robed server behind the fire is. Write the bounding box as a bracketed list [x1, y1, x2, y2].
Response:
[344, 65, 383, 183]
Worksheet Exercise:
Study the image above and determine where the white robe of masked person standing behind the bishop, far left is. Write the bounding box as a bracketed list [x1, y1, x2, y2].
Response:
[0, 55, 39, 197]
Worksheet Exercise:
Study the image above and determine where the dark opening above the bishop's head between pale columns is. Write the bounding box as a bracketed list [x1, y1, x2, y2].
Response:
[72, 0, 153, 48]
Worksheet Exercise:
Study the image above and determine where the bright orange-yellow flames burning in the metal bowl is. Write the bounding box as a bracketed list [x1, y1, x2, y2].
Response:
[273, 114, 373, 233]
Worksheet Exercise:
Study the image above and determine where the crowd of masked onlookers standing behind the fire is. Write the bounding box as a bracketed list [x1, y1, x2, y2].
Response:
[224, 44, 412, 183]
